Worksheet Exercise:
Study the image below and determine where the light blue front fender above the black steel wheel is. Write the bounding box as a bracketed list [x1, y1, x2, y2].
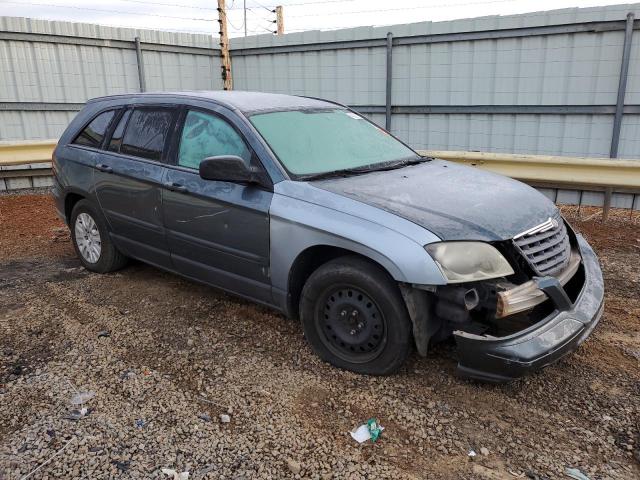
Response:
[270, 181, 446, 312]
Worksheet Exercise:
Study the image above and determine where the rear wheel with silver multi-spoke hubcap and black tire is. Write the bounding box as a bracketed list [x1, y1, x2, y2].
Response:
[69, 200, 127, 273]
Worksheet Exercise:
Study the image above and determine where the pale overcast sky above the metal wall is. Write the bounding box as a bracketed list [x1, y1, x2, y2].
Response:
[0, 0, 625, 37]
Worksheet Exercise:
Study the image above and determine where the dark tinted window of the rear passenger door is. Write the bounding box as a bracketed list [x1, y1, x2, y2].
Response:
[120, 108, 173, 160]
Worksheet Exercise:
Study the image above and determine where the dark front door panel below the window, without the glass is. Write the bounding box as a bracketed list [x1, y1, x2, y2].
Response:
[162, 168, 273, 303]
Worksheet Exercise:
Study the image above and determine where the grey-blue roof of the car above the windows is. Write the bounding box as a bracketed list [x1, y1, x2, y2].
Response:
[92, 90, 342, 113]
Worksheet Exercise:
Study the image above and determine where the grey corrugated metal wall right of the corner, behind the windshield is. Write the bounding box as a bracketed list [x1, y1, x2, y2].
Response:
[231, 4, 640, 158]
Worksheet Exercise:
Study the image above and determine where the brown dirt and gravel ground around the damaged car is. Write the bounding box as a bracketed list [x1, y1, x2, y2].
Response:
[0, 194, 640, 480]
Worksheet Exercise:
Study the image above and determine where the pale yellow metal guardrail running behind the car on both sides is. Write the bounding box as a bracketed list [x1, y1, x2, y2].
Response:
[0, 140, 640, 217]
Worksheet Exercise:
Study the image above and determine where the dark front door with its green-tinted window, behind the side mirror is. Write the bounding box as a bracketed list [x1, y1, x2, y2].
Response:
[162, 109, 273, 303]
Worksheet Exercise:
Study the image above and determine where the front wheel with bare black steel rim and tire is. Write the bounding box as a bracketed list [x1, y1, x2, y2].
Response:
[300, 256, 412, 375]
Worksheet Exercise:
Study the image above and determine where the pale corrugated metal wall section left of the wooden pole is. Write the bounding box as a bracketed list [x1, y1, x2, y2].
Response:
[0, 17, 222, 140]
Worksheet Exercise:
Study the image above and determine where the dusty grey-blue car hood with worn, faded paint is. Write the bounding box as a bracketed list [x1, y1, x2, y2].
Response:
[312, 160, 557, 241]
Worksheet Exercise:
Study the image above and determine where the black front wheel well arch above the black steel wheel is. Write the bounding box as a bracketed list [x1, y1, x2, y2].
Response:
[287, 245, 391, 318]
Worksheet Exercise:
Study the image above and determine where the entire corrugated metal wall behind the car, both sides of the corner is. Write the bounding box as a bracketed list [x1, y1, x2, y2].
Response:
[0, 4, 640, 158]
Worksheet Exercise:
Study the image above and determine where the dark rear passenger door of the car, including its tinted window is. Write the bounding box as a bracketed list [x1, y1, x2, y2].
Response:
[95, 106, 177, 268]
